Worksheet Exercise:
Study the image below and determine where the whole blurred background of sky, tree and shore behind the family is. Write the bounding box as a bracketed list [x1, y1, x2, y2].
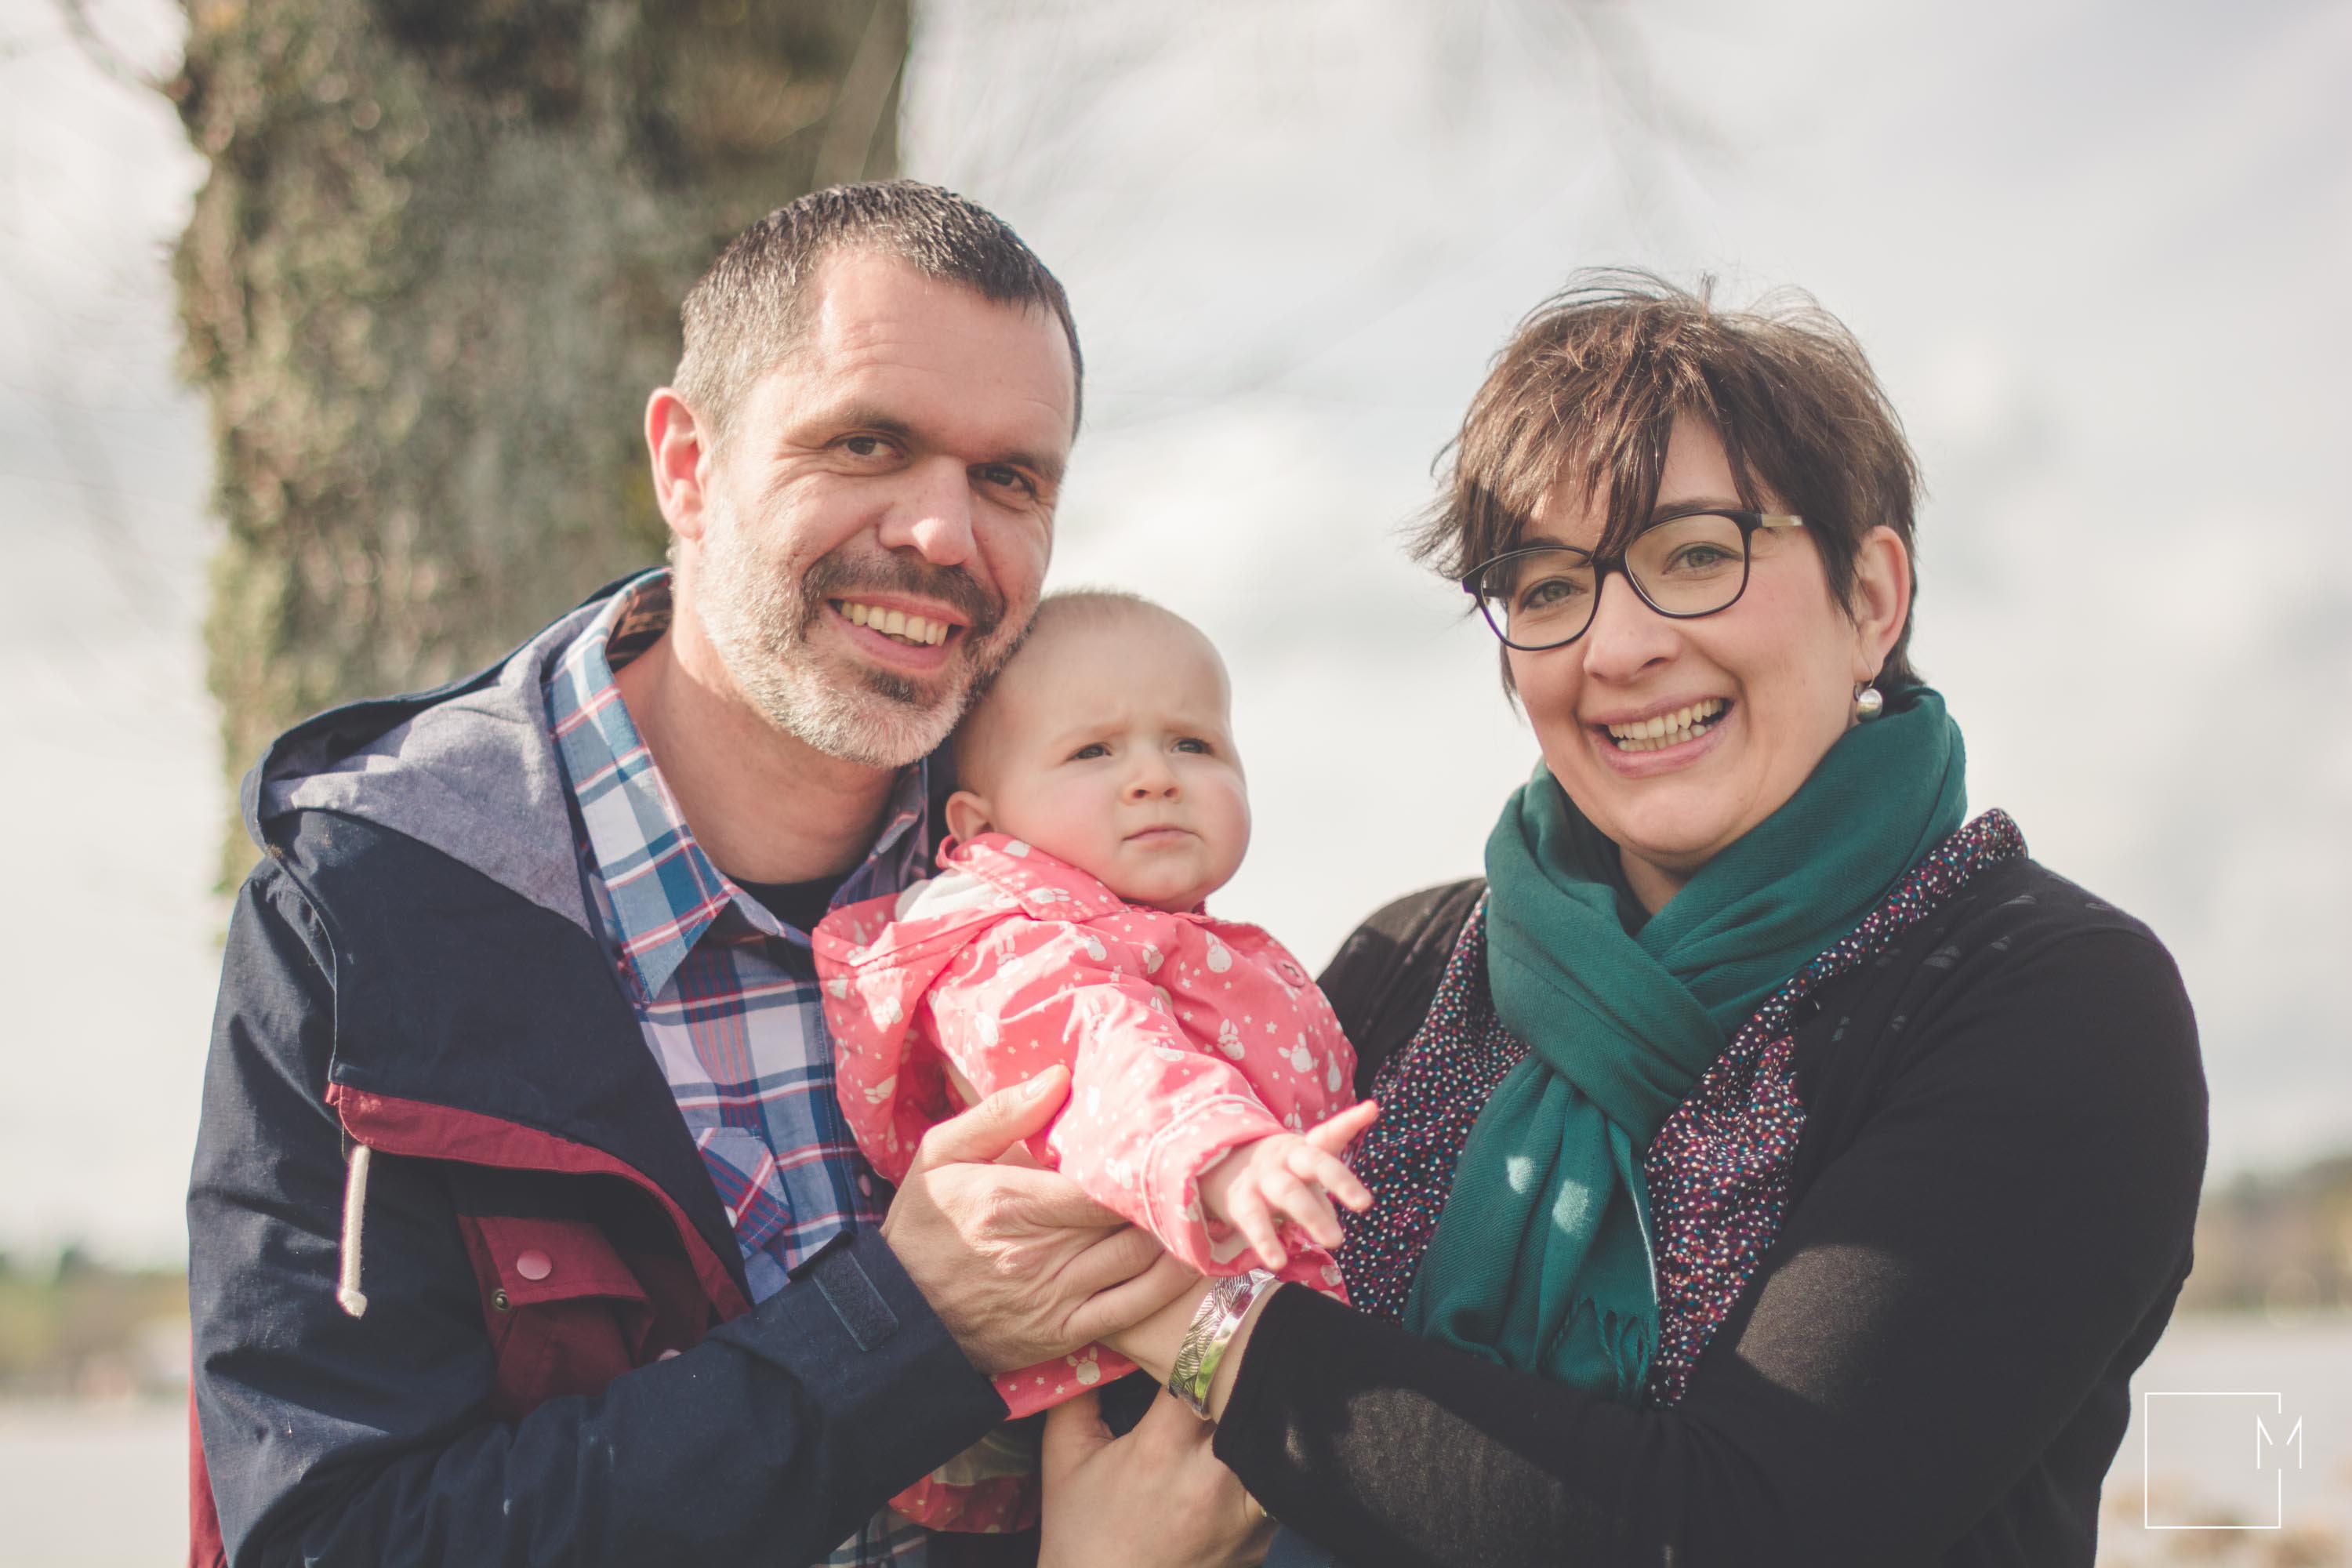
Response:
[0, 0, 2352, 1566]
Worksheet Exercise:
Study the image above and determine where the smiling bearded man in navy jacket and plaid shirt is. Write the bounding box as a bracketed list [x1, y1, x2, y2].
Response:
[188, 183, 1183, 1568]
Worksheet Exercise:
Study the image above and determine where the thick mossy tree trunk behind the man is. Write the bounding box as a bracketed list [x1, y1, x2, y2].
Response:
[174, 0, 910, 881]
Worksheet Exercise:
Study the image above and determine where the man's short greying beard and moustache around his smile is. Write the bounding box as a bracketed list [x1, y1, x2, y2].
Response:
[694, 503, 1014, 769]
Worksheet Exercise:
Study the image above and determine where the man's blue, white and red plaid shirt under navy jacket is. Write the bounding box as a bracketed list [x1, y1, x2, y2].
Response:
[548, 572, 931, 1566]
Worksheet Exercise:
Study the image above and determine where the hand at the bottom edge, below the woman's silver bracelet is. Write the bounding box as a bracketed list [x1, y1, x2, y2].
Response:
[1037, 1392, 1275, 1568]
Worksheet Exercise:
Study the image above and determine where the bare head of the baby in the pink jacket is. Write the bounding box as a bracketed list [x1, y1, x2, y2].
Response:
[967, 614, 1249, 909]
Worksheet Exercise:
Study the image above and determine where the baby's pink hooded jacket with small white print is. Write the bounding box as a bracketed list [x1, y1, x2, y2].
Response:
[816, 832, 1355, 1415]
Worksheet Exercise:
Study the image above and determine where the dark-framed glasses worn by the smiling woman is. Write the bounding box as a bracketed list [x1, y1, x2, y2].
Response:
[1463, 510, 1804, 654]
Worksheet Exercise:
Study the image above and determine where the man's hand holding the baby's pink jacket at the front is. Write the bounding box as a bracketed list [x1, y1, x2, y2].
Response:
[882, 1065, 1192, 1373]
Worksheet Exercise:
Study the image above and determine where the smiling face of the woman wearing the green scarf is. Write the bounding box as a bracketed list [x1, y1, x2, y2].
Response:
[1510, 419, 1910, 909]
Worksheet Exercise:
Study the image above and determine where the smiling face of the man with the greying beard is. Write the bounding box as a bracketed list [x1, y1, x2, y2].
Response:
[673, 252, 1077, 767]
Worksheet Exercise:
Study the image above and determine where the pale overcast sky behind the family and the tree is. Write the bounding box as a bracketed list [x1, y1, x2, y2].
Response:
[0, 0, 2352, 1258]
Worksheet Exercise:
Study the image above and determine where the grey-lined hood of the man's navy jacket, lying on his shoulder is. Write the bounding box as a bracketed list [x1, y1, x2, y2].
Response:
[242, 574, 644, 928]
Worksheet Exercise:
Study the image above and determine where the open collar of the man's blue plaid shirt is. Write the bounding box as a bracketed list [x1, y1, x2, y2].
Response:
[548, 572, 931, 999]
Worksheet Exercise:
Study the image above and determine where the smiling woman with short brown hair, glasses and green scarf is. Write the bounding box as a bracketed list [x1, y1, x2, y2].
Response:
[1044, 278, 2206, 1568]
